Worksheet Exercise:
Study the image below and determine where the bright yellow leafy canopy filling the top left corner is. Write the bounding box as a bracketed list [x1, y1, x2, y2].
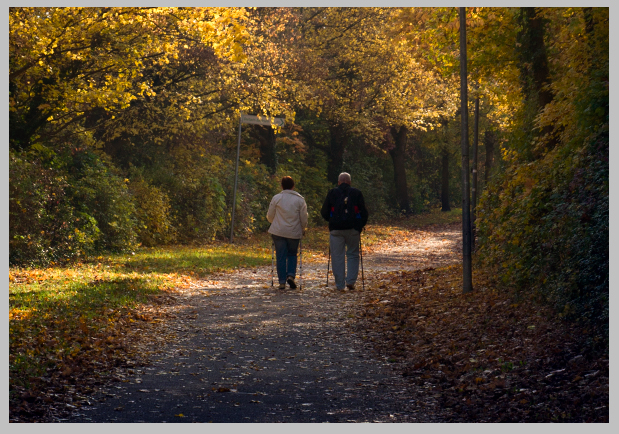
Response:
[9, 8, 247, 149]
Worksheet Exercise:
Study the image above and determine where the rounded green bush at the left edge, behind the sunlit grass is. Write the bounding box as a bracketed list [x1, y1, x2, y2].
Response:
[9, 145, 136, 264]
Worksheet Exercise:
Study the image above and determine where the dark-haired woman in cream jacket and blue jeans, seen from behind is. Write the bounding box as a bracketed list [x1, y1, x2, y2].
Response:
[267, 176, 307, 289]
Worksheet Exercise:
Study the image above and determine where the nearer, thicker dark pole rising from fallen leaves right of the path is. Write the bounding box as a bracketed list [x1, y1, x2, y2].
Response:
[459, 8, 473, 294]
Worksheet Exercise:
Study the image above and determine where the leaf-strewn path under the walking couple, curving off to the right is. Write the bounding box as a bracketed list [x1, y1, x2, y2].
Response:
[74, 224, 461, 423]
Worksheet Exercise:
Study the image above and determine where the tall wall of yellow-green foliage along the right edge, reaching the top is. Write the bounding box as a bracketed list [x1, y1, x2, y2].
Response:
[478, 8, 609, 349]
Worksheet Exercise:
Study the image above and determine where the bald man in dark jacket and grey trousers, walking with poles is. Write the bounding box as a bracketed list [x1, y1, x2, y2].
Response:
[320, 172, 368, 291]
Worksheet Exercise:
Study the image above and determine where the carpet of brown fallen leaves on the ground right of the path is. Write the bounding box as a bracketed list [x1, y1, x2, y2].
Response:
[357, 265, 609, 422]
